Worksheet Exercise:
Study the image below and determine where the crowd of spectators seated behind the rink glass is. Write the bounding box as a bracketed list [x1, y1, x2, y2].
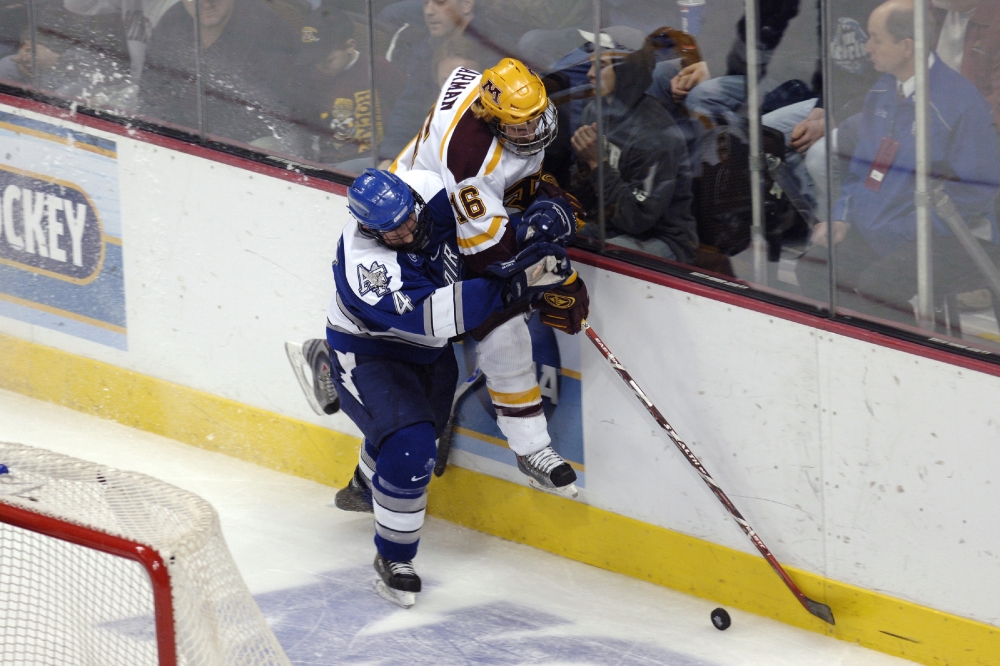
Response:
[0, 0, 1000, 345]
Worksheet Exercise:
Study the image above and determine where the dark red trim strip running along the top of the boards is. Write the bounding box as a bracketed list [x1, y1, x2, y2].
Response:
[0, 93, 1000, 376]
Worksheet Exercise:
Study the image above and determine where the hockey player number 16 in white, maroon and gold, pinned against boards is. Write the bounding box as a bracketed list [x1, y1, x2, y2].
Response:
[390, 58, 589, 496]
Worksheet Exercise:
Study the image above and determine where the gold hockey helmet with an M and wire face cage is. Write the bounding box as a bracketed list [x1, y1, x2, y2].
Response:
[479, 58, 558, 155]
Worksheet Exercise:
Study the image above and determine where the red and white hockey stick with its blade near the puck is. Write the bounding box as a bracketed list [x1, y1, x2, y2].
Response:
[582, 320, 835, 624]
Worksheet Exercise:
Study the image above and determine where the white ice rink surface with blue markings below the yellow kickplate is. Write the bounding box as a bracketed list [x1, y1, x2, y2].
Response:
[0, 391, 912, 666]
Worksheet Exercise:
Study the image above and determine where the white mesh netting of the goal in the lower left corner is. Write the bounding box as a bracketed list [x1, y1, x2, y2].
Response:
[0, 442, 289, 666]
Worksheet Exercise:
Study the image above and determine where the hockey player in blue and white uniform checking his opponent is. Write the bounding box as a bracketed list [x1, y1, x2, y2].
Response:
[327, 169, 574, 608]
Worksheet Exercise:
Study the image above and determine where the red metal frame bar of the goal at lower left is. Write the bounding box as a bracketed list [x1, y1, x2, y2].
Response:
[0, 502, 177, 666]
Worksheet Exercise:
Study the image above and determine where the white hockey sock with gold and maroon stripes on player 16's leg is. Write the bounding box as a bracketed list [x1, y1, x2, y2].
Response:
[478, 316, 552, 456]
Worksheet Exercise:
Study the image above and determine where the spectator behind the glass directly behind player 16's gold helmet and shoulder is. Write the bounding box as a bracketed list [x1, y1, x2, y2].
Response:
[379, 0, 511, 163]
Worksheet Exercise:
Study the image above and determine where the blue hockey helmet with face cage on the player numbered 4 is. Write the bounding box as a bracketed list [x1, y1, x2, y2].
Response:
[347, 169, 429, 252]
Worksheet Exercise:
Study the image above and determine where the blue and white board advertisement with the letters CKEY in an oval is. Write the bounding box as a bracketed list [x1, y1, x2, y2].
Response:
[0, 112, 128, 349]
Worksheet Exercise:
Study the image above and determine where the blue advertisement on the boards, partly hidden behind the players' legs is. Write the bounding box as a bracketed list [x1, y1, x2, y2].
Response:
[452, 313, 587, 488]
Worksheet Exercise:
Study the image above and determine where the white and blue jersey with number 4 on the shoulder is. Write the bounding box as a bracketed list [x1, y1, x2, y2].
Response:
[326, 171, 503, 363]
